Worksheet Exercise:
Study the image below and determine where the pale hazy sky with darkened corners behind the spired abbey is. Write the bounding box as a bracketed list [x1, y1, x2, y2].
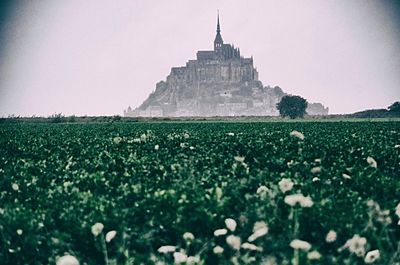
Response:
[0, 0, 400, 116]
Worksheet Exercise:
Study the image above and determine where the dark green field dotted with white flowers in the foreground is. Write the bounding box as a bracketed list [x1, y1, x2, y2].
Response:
[0, 122, 400, 265]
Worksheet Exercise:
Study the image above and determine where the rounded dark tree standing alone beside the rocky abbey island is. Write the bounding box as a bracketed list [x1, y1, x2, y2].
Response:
[276, 96, 308, 119]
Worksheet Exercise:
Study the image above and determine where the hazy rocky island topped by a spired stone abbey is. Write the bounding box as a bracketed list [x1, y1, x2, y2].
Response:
[124, 16, 328, 117]
